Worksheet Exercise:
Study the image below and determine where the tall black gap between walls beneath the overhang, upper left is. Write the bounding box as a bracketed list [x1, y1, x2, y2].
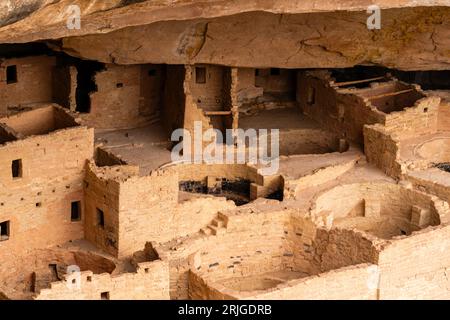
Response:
[76, 60, 104, 113]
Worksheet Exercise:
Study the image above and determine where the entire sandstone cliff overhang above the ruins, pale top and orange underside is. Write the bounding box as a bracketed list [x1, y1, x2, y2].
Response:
[0, 0, 450, 70]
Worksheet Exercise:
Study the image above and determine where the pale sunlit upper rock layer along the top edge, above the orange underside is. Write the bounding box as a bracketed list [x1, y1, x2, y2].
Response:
[0, 0, 449, 43]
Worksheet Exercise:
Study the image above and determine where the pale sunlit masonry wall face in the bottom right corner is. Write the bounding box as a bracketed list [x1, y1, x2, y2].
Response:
[379, 225, 450, 300]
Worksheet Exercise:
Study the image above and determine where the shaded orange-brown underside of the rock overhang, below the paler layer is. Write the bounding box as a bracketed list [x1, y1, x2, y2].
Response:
[62, 8, 450, 70]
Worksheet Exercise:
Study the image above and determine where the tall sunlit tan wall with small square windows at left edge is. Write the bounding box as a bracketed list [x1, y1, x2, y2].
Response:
[0, 117, 94, 257]
